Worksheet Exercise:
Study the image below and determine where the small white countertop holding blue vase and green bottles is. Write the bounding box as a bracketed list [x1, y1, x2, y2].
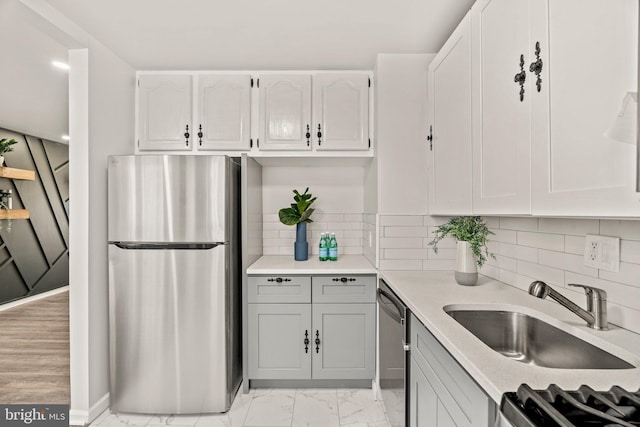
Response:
[247, 255, 377, 274]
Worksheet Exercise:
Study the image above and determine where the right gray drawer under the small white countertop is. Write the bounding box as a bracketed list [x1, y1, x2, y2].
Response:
[312, 275, 376, 303]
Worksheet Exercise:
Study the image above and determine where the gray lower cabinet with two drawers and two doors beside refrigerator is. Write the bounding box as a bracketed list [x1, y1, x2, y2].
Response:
[246, 276, 376, 380]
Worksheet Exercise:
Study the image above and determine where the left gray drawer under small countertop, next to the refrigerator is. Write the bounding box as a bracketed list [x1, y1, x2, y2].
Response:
[247, 276, 311, 303]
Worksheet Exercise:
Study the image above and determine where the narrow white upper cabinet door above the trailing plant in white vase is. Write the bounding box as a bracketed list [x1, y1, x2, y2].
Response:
[427, 14, 472, 215]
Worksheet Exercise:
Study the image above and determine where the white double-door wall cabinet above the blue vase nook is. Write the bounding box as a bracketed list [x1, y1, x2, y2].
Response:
[258, 73, 370, 151]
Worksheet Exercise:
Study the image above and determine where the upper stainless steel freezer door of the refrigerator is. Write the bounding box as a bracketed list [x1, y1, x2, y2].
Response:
[108, 156, 232, 242]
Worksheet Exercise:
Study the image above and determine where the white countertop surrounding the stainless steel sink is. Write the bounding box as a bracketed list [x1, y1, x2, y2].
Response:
[380, 271, 640, 403]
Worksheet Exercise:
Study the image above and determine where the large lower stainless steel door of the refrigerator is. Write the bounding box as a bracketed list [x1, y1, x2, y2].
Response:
[109, 245, 241, 414]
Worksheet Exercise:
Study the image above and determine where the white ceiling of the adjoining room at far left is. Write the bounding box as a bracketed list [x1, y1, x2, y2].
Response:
[0, 0, 69, 142]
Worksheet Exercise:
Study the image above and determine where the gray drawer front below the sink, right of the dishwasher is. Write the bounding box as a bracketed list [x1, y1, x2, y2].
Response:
[411, 315, 492, 426]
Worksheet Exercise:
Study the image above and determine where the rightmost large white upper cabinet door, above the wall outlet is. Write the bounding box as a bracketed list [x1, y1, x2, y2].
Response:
[528, 0, 640, 217]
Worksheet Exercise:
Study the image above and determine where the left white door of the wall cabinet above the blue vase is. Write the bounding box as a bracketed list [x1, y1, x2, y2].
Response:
[258, 75, 312, 150]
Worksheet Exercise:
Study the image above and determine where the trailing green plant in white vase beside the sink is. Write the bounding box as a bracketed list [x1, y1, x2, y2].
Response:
[429, 216, 495, 285]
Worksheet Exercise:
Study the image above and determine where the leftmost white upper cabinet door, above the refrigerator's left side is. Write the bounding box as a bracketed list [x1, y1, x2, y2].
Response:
[137, 74, 194, 151]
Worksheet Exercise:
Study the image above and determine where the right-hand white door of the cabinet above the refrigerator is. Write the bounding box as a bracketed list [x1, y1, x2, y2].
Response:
[194, 74, 251, 151]
